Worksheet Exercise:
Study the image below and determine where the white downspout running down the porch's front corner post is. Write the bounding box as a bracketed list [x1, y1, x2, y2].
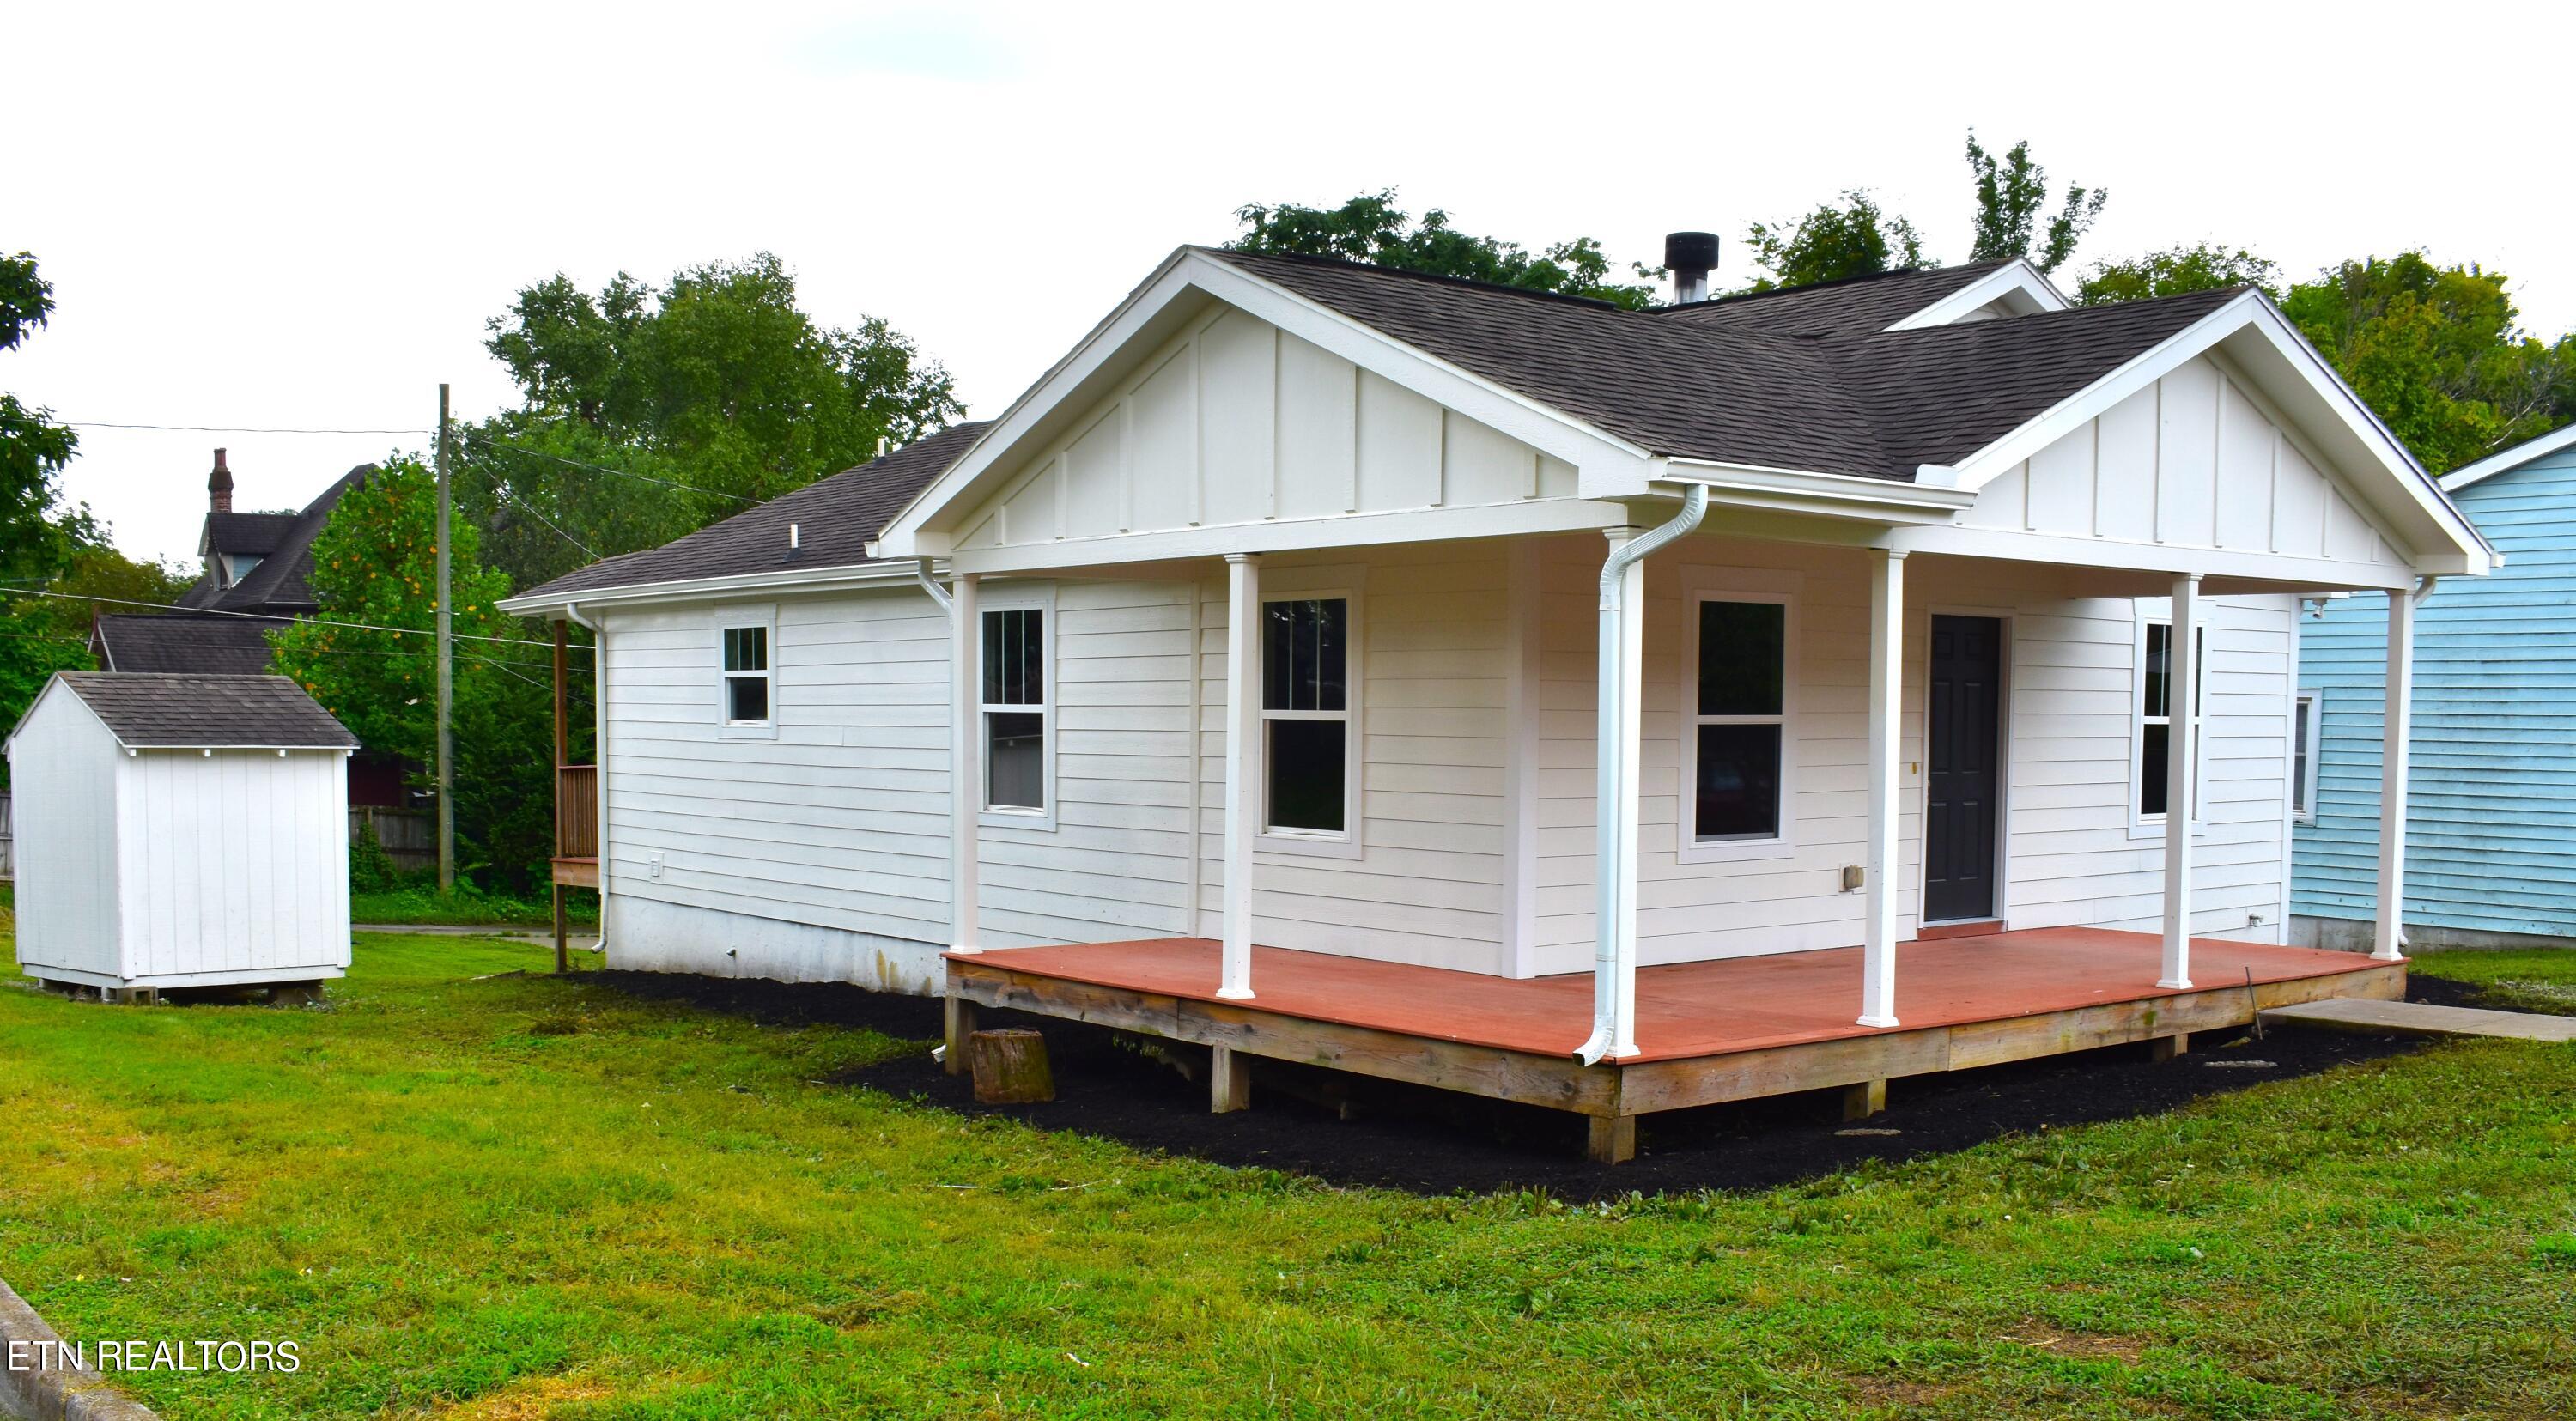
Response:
[1574, 484, 1708, 1066]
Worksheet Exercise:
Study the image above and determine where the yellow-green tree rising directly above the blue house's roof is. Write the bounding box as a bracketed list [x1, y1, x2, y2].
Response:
[2282, 252, 2576, 474]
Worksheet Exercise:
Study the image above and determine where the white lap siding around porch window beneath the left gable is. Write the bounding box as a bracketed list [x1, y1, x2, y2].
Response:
[1198, 544, 1510, 973]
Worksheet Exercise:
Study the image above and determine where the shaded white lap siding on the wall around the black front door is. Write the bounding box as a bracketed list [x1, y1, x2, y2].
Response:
[1535, 538, 2293, 973]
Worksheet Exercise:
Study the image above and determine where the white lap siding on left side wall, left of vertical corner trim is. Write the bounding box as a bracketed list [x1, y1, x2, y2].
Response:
[605, 582, 1190, 947]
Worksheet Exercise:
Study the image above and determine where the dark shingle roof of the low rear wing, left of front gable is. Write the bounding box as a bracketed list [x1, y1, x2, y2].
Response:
[510, 420, 992, 600]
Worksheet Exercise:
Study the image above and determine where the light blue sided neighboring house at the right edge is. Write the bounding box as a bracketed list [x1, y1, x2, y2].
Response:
[2290, 425, 2576, 950]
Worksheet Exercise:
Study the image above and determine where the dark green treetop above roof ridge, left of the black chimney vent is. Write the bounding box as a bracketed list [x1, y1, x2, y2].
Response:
[1226, 188, 1659, 309]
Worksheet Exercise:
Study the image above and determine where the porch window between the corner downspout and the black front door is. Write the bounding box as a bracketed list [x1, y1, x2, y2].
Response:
[1690, 598, 1788, 844]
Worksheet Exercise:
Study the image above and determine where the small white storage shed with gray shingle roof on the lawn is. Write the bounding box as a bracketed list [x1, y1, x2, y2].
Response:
[8, 672, 358, 993]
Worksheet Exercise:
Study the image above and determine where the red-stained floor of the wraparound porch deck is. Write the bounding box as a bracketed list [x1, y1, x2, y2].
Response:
[958, 926, 2380, 1060]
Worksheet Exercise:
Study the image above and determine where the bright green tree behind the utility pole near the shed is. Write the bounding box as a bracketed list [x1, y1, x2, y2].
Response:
[268, 456, 554, 893]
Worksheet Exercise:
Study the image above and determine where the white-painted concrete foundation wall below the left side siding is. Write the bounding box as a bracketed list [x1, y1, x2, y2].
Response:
[603, 893, 945, 996]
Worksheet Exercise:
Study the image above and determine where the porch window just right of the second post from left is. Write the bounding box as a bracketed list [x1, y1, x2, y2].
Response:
[1262, 598, 1350, 834]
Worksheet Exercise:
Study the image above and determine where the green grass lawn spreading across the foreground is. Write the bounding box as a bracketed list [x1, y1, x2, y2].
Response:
[0, 937, 2576, 1421]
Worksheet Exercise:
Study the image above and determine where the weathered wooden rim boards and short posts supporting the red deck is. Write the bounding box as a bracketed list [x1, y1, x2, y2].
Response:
[948, 950, 2406, 1163]
